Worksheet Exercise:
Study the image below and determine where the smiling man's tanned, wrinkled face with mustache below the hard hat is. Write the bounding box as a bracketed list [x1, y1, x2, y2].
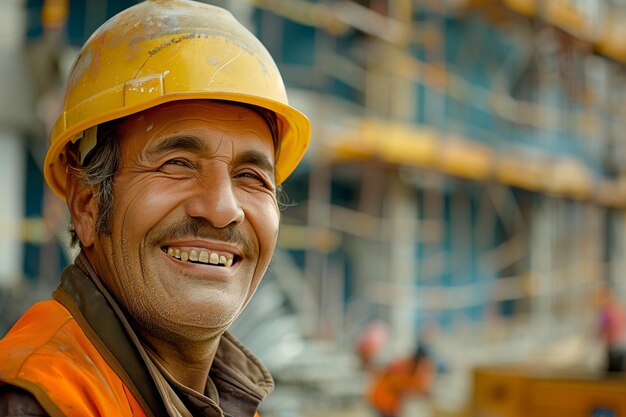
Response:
[88, 100, 279, 339]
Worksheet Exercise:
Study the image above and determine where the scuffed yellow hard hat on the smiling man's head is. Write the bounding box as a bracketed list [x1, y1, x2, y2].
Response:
[44, 0, 310, 197]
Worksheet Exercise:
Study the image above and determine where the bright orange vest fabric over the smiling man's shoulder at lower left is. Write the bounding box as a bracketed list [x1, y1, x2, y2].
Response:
[0, 300, 146, 417]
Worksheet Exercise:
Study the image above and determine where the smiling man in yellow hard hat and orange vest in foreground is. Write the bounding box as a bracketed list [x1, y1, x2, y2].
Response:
[0, 0, 310, 417]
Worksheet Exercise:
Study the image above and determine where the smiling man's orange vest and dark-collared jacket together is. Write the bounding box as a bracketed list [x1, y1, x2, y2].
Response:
[0, 253, 273, 417]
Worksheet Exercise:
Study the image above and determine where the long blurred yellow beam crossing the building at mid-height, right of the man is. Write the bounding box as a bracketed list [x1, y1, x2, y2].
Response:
[324, 118, 626, 208]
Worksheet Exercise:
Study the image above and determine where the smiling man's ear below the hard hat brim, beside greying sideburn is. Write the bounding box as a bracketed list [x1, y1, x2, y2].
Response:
[65, 173, 98, 248]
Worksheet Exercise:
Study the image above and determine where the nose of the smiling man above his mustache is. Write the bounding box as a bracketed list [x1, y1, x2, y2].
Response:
[187, 173, 245, 228]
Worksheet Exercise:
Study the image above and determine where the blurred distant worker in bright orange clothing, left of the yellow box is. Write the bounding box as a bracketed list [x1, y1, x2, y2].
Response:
[367, 345, 437, 417]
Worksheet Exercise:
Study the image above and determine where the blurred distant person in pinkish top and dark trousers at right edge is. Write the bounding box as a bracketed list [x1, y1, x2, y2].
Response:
[596, 287, 626, 372]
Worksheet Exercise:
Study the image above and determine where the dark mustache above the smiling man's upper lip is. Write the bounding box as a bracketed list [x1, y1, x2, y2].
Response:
[156, 217, 254, 257]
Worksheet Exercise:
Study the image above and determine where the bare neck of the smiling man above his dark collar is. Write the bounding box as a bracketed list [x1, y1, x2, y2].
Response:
[138, 326, 221, 393]
